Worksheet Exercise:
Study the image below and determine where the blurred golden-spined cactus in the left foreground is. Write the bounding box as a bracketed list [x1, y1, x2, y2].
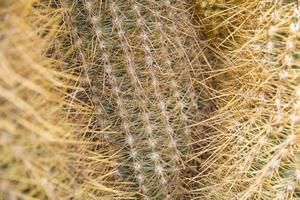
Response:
[0, 0, 121, 200]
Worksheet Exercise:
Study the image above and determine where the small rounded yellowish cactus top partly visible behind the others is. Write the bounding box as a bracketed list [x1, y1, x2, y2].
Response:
[194, 0, 259, 44]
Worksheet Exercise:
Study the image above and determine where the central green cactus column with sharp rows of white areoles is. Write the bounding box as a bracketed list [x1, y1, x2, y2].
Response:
[46, 0, 207, 199]
